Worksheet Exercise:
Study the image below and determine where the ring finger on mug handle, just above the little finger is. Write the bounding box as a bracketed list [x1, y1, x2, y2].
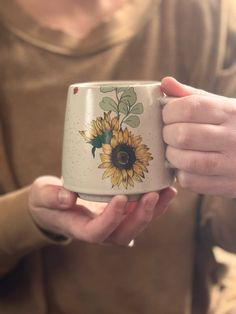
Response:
[166, 146, 233, 176]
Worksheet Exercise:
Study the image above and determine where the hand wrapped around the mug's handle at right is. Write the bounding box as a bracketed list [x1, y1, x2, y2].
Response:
[162, 77, 236, 198]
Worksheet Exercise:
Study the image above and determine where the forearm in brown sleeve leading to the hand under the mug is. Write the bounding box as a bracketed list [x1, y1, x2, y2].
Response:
[0, 187, 58, 277]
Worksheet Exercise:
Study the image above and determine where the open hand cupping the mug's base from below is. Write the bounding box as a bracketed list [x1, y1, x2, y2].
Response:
[29, 176, 176, 246]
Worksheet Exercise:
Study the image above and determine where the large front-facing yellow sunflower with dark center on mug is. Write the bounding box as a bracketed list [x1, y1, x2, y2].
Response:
[98, 128, 153, 189]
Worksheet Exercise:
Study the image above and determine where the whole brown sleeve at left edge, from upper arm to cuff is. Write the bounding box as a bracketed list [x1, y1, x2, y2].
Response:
[0, 123, 70, 277]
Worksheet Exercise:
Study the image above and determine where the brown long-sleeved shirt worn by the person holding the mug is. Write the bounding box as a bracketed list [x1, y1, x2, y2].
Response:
[0, 0, 236, 314]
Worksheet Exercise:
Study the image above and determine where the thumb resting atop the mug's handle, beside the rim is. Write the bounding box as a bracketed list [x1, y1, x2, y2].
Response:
[161, 76, 210, 97]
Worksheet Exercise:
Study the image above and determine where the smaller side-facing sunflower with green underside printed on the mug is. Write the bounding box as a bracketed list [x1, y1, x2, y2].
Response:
[79, 111, 119, 157]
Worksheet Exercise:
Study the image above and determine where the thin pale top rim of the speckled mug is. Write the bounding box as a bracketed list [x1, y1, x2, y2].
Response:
[70, 80, 161, 88]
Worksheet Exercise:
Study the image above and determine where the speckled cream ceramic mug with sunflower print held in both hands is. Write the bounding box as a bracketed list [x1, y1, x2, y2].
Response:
[62, 81, 173, 202]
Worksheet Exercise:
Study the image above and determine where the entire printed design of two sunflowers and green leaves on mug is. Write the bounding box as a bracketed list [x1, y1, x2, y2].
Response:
[79, 86, 153, 189]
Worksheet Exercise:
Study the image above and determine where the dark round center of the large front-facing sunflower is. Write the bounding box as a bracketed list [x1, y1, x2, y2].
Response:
[111, 144, 136, 170]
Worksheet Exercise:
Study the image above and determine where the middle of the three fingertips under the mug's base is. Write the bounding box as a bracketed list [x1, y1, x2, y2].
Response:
[109, 192, 159, 245]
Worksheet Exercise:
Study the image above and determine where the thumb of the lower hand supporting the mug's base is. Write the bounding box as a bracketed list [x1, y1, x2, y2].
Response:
[30, 182, 77, 209]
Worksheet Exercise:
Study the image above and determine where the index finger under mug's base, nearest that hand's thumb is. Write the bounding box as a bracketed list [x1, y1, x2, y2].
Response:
[81, 195, 128, 243]
